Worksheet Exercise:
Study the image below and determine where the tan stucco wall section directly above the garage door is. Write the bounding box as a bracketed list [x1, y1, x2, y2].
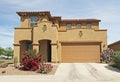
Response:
[58, 29, 107, 49]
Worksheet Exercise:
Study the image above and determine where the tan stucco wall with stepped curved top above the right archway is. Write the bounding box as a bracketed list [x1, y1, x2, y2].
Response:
[33, 22, 58, 44]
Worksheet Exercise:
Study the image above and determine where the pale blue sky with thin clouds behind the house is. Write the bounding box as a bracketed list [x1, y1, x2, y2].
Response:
[0, 0, 120, 47]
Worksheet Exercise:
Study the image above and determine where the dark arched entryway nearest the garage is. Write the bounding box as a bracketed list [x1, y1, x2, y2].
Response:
[39, 40, 51, 62]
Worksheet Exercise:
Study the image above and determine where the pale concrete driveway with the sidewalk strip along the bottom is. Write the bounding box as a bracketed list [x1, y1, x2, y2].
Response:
[0, 63, 120, 82]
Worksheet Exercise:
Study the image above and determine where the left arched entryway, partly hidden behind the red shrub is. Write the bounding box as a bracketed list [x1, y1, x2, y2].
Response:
[19, 40, 32, 62]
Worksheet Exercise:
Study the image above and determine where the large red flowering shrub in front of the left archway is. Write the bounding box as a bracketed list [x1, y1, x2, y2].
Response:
[20, 51, 41, 71]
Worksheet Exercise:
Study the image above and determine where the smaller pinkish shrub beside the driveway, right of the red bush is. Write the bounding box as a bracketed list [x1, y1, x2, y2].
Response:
[38, 62, 53, 74]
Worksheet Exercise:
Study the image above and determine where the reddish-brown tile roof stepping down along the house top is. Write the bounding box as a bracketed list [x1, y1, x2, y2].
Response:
[16, 11, 101, 23]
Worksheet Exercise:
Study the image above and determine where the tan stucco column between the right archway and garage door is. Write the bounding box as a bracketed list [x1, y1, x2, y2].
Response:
[51, 44, 58, 63]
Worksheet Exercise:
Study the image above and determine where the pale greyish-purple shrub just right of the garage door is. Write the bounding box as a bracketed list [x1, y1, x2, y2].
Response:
[100, 48, 114, 63]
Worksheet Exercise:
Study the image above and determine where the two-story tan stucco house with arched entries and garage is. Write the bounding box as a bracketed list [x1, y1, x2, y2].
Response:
[14, 11, 107, 62]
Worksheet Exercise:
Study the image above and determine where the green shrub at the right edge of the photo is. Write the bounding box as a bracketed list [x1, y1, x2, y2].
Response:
[112, 51, 120, 69]
